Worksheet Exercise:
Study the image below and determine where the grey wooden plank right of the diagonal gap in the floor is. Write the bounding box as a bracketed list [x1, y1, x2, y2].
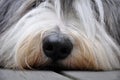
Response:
[63, 71, 120, 80]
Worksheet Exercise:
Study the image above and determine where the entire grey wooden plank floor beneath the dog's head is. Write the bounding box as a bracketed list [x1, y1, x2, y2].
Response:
[0, 69, 120, 80]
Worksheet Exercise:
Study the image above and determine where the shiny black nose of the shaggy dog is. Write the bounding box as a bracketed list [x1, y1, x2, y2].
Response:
[43, 35, 73, 61]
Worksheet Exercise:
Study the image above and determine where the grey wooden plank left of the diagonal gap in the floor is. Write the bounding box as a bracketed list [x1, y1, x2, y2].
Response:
[0, 69, 70, 80]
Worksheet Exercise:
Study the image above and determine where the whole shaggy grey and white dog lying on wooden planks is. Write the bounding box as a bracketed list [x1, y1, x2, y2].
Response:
[0, 0, 120, 70]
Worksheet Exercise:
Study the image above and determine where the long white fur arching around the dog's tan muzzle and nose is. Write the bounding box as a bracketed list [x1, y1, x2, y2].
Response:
[0, 0, 120, 70]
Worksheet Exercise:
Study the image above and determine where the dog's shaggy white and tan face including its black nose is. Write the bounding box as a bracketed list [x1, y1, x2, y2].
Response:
[2, 0, 119, 70]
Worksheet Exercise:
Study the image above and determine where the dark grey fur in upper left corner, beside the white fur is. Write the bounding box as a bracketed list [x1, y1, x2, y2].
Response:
[0, 0, 44, 33]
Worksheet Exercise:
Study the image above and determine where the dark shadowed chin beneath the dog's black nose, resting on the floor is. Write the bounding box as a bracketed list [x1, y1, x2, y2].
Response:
[28, 61, 99, 72]
